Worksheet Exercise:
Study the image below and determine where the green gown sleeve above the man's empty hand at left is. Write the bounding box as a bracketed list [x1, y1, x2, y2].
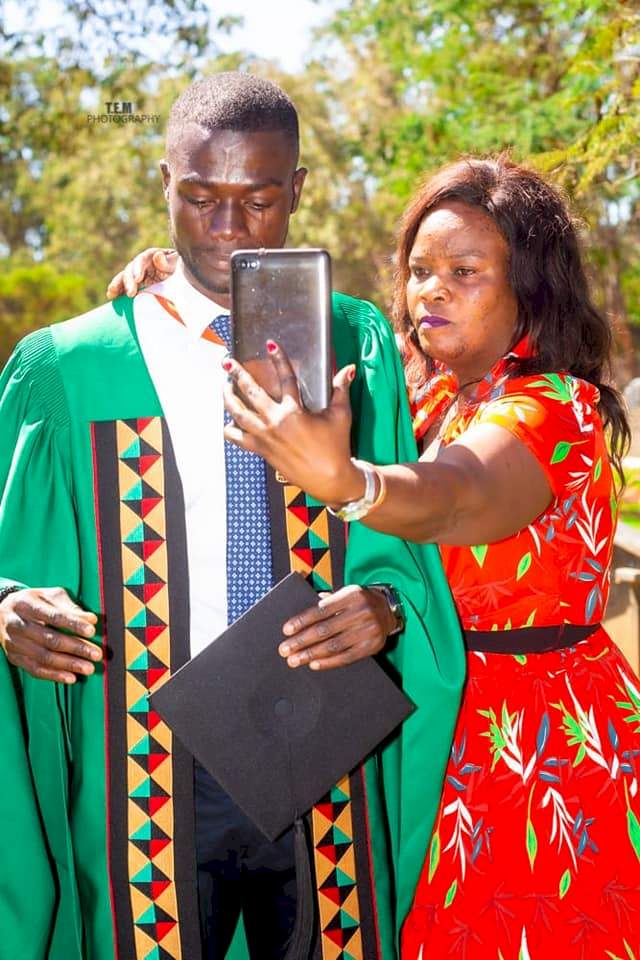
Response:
[0, 331, 79, 596]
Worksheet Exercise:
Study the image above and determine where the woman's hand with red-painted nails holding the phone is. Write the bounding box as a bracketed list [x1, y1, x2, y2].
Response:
[223, 341, 365, 504]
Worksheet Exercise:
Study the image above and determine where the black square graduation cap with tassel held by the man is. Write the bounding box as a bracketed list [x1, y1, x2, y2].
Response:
[150, 573, 413, 957]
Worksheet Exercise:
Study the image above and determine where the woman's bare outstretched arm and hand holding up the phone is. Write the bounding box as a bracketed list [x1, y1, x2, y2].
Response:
[225, 348, 552, 545]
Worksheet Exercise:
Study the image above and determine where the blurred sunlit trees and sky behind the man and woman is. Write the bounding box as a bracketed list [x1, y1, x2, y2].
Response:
[0, 0, 640, 667]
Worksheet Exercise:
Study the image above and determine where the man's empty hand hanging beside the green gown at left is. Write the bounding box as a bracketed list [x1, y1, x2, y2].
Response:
[0, 587, 102, 683]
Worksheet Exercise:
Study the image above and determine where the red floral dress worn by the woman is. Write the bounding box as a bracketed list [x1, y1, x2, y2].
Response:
[402, 350, 640, 960]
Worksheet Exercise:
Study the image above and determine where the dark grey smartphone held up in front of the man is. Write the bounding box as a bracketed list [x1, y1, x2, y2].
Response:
[231, 248, 331, 413]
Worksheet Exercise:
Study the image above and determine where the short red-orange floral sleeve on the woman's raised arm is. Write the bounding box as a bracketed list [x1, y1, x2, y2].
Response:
[473, 374, 606, 497]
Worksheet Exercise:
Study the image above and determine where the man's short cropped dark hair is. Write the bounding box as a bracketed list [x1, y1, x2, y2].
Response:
[167, 71, 299, 156]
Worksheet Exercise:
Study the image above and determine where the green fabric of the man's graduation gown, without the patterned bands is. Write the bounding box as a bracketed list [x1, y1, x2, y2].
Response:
[0, 295, 464, 960]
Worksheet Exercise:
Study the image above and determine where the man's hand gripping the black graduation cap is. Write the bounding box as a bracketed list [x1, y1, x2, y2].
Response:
[278, 586, 396, 670]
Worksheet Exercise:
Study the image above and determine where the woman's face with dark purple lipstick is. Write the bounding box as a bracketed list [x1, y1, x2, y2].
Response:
[407, 201, 518, 383]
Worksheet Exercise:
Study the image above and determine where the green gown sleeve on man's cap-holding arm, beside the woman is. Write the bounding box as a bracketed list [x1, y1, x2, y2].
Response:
[338, 300, 465, 944]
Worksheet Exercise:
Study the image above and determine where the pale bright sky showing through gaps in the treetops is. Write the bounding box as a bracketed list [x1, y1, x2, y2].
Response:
[3, 0, 335, 72]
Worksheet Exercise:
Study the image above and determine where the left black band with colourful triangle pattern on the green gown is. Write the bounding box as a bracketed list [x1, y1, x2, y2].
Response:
[92, 417, 201, 960]
